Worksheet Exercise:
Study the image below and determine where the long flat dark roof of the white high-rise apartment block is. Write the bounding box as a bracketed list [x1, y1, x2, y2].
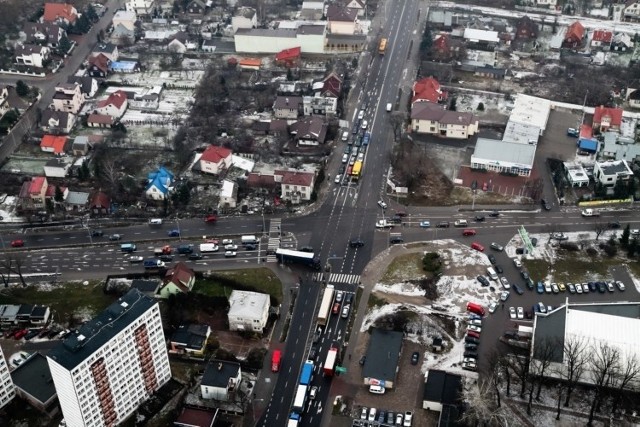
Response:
[47, 289, 157, 370]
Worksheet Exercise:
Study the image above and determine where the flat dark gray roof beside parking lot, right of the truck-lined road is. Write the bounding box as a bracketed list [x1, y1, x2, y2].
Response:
[362, 329, 402, 381]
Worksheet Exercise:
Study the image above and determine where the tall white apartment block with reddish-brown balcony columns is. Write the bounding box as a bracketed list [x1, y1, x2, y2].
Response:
[47, 289, 171, 427]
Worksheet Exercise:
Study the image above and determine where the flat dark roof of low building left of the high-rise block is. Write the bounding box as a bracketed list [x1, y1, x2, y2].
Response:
[11, 353, 56, 404]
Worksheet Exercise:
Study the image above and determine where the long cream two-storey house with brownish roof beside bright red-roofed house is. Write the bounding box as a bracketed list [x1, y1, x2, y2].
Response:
[411, 102, 478, 139]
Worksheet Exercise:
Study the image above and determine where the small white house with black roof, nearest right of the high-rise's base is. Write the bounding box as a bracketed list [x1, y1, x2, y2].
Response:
[200, 360, 242, 401]
